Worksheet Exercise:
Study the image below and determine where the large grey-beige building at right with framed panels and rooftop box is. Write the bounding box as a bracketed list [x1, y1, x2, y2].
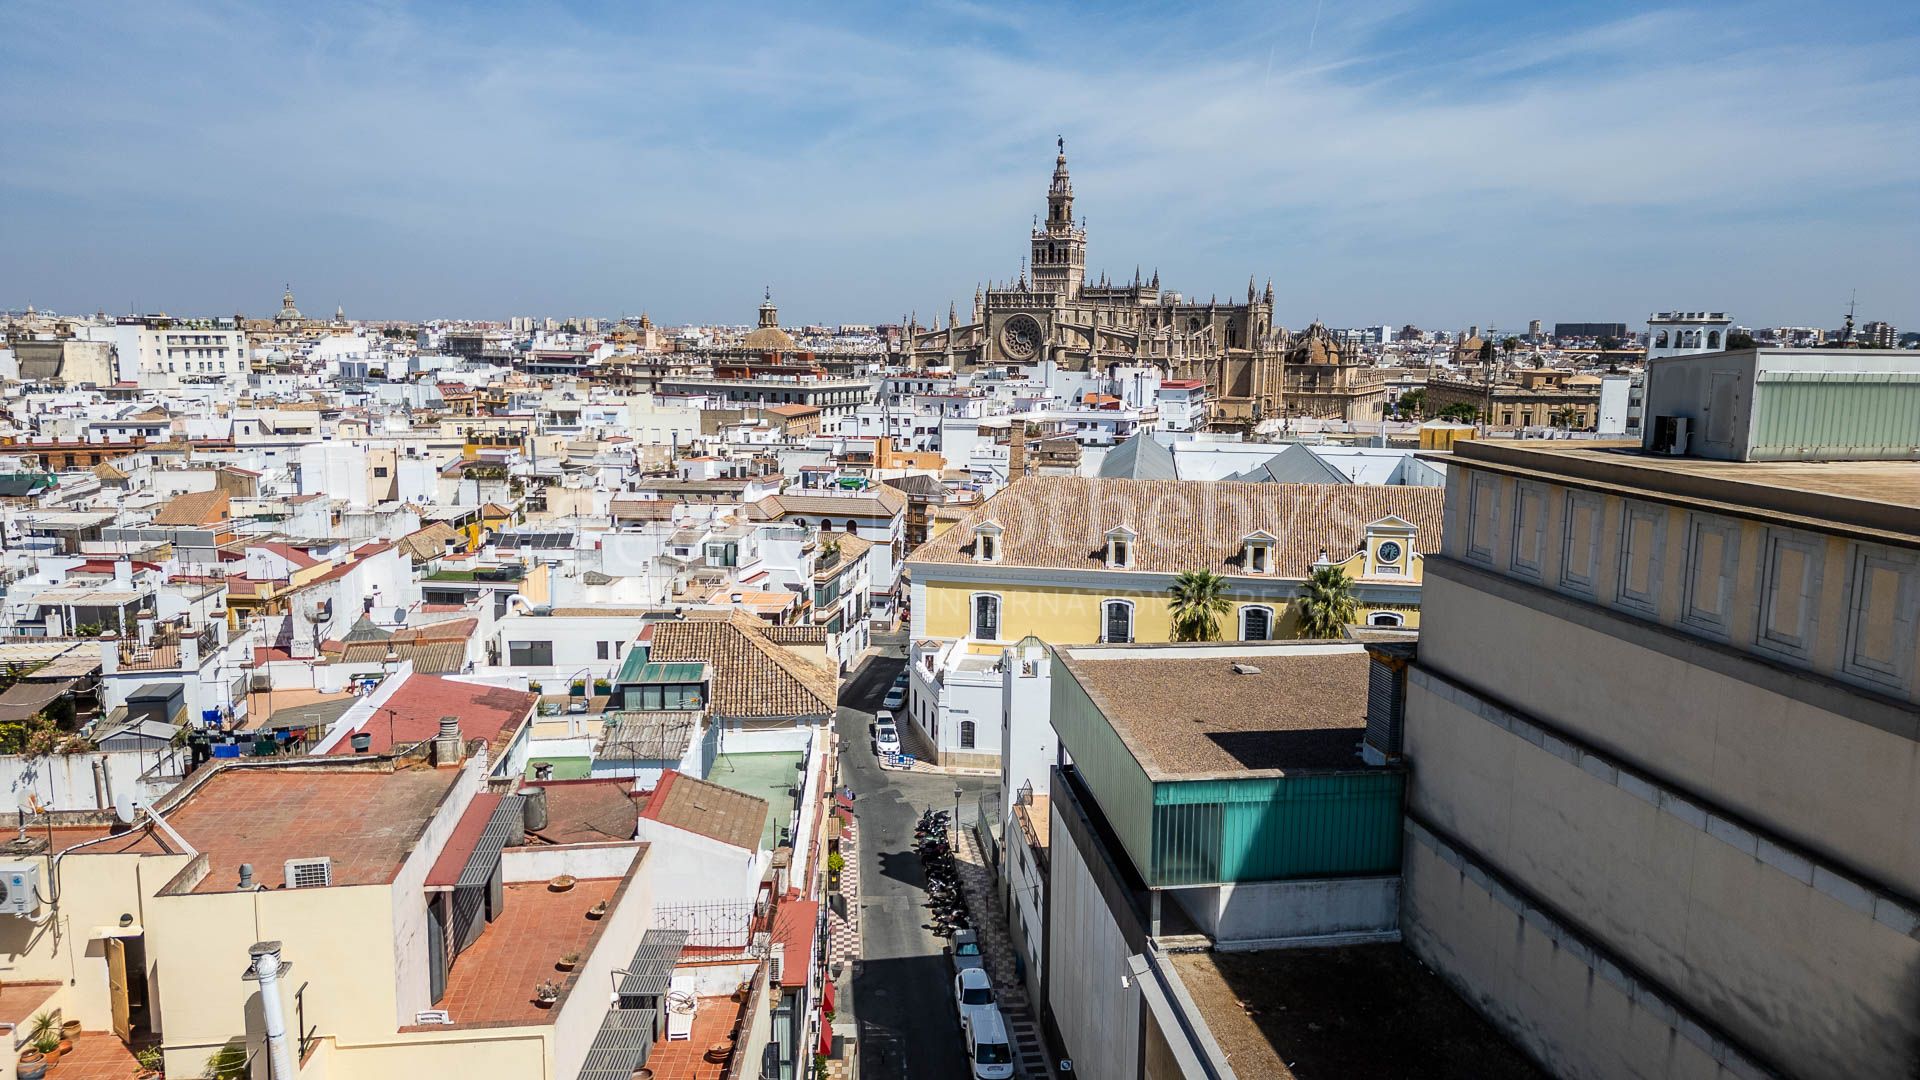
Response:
[1397, 350, 1920, 1078]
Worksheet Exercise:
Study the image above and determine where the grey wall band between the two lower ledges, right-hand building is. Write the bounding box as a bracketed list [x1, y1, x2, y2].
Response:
[1407, 668, 1920, 1076]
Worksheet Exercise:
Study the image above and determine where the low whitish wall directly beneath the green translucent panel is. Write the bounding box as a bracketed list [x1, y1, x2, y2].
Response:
[1167, 874, 1400, 949]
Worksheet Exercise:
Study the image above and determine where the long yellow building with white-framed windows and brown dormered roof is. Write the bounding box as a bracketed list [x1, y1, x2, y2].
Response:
[908, 477, 1442, 641]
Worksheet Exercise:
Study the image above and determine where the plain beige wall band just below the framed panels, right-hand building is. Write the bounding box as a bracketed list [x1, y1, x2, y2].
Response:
[1407, 557, 1920, 896]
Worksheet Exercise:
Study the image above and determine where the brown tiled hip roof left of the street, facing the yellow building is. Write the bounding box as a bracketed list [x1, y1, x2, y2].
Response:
[649, 611, 839, 719]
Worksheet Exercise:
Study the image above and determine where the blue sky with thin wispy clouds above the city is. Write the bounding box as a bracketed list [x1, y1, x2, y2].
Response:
[0, 0, 1920, 331]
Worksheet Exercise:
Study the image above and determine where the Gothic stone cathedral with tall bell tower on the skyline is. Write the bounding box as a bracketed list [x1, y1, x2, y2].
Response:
[900, 140, 1286, 429]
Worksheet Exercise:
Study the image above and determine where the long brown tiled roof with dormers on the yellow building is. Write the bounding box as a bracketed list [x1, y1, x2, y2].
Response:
[910, 477, 1446, 578]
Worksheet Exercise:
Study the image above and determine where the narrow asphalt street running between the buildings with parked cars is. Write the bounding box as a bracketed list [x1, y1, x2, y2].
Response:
[839, 648, 998, 1080]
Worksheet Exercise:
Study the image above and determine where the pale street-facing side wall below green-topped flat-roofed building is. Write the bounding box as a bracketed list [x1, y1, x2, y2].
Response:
[1046, 803, 1140, 1080]
